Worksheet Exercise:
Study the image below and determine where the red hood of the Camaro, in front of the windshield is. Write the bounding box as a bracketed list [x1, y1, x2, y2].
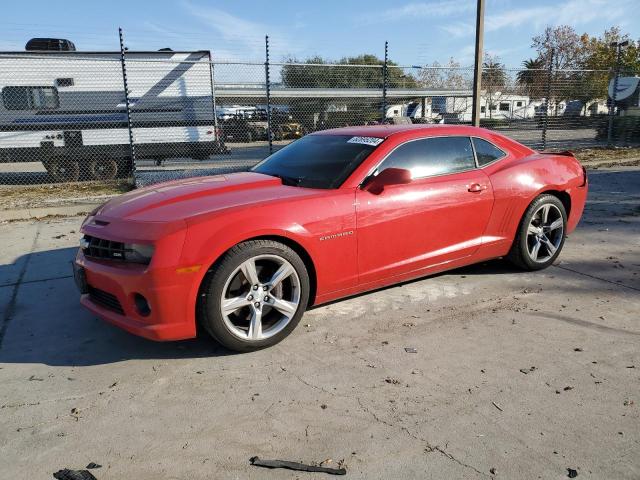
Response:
[96, 172, 318, 222]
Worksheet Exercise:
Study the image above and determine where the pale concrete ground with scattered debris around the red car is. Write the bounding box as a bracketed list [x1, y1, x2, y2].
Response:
[0, 167, 640, 480]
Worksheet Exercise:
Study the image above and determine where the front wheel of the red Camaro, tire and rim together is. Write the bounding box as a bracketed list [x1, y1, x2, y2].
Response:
[198, 240, 309, 352]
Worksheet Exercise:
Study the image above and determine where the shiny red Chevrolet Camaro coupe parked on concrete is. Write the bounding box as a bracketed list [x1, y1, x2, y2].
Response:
[74, 125, 587, 351]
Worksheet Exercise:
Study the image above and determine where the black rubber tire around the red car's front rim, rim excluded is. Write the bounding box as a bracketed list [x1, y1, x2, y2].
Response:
[197, 240, 310, 352]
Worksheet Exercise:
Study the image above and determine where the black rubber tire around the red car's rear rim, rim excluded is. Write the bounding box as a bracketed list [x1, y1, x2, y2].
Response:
[507, 194, 567, 271]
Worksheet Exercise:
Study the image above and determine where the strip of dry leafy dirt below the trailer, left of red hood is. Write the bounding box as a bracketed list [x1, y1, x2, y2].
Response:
[0, 180, 133, 210]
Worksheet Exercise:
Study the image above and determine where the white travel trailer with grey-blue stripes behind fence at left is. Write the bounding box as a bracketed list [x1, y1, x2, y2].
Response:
[0, 47, 227, 180]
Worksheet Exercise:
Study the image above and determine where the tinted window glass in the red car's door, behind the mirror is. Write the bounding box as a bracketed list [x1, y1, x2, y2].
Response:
[378, 137, 475, 178]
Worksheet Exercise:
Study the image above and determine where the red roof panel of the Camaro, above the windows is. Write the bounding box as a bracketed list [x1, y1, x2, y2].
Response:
[313, 124, 496, 138]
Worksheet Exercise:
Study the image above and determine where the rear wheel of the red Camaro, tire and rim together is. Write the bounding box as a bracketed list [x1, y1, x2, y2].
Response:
[507, 194, 567, 270]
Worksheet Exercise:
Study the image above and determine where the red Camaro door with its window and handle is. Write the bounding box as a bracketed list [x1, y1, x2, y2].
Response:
[356, 136, 493, 284]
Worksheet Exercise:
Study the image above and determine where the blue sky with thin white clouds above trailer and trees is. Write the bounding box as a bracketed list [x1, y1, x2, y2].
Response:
[0, 0, 640, 67]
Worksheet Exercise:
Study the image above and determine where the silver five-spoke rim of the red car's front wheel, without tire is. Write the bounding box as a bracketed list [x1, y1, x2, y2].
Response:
[220, 255, 300, 341]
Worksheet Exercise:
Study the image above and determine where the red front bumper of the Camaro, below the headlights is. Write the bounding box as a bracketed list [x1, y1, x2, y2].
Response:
[75, 250, 197, 341]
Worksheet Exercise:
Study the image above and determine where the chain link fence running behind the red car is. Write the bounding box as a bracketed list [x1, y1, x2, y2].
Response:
[0, 44, 640, 188]
